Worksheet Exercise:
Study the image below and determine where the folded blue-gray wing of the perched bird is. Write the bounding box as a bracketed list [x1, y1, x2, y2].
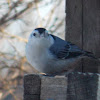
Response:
[49, 35, 84, 59]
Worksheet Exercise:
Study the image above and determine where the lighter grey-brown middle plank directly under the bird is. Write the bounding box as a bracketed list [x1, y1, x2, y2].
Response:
[41, 77, 67, 100]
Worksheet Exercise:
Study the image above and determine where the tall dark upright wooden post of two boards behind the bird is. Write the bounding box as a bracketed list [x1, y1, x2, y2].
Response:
[65, 0, 100, 73]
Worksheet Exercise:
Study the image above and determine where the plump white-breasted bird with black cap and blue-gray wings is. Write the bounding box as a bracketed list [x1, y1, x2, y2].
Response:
[25, 28, 95, 76]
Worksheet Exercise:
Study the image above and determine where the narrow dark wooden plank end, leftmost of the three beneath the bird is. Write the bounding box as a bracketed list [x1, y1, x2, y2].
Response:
[24, 74, 41, 100]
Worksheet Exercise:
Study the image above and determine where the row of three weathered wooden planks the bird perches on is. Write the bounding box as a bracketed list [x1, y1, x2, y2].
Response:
[24, 72, 100, 100]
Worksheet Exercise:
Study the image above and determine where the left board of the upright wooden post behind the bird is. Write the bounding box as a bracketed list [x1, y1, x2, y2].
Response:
[65, 0, 82, 71]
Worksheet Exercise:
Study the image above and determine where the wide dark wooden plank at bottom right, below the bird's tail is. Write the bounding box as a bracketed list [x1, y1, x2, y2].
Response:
[67, 73, 100, 100]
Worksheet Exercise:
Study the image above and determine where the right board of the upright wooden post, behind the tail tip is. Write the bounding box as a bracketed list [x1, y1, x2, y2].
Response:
[83, 0, 100, 72]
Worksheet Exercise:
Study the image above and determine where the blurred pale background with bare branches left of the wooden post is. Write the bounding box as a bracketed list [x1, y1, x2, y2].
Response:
[0, 0, 65, 100]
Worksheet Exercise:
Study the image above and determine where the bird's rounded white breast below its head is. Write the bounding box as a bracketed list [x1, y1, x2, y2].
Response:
[26, 35, 53, 72]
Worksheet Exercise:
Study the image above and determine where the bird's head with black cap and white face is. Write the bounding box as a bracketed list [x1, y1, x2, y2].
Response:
[29, 28, 53, 45]
